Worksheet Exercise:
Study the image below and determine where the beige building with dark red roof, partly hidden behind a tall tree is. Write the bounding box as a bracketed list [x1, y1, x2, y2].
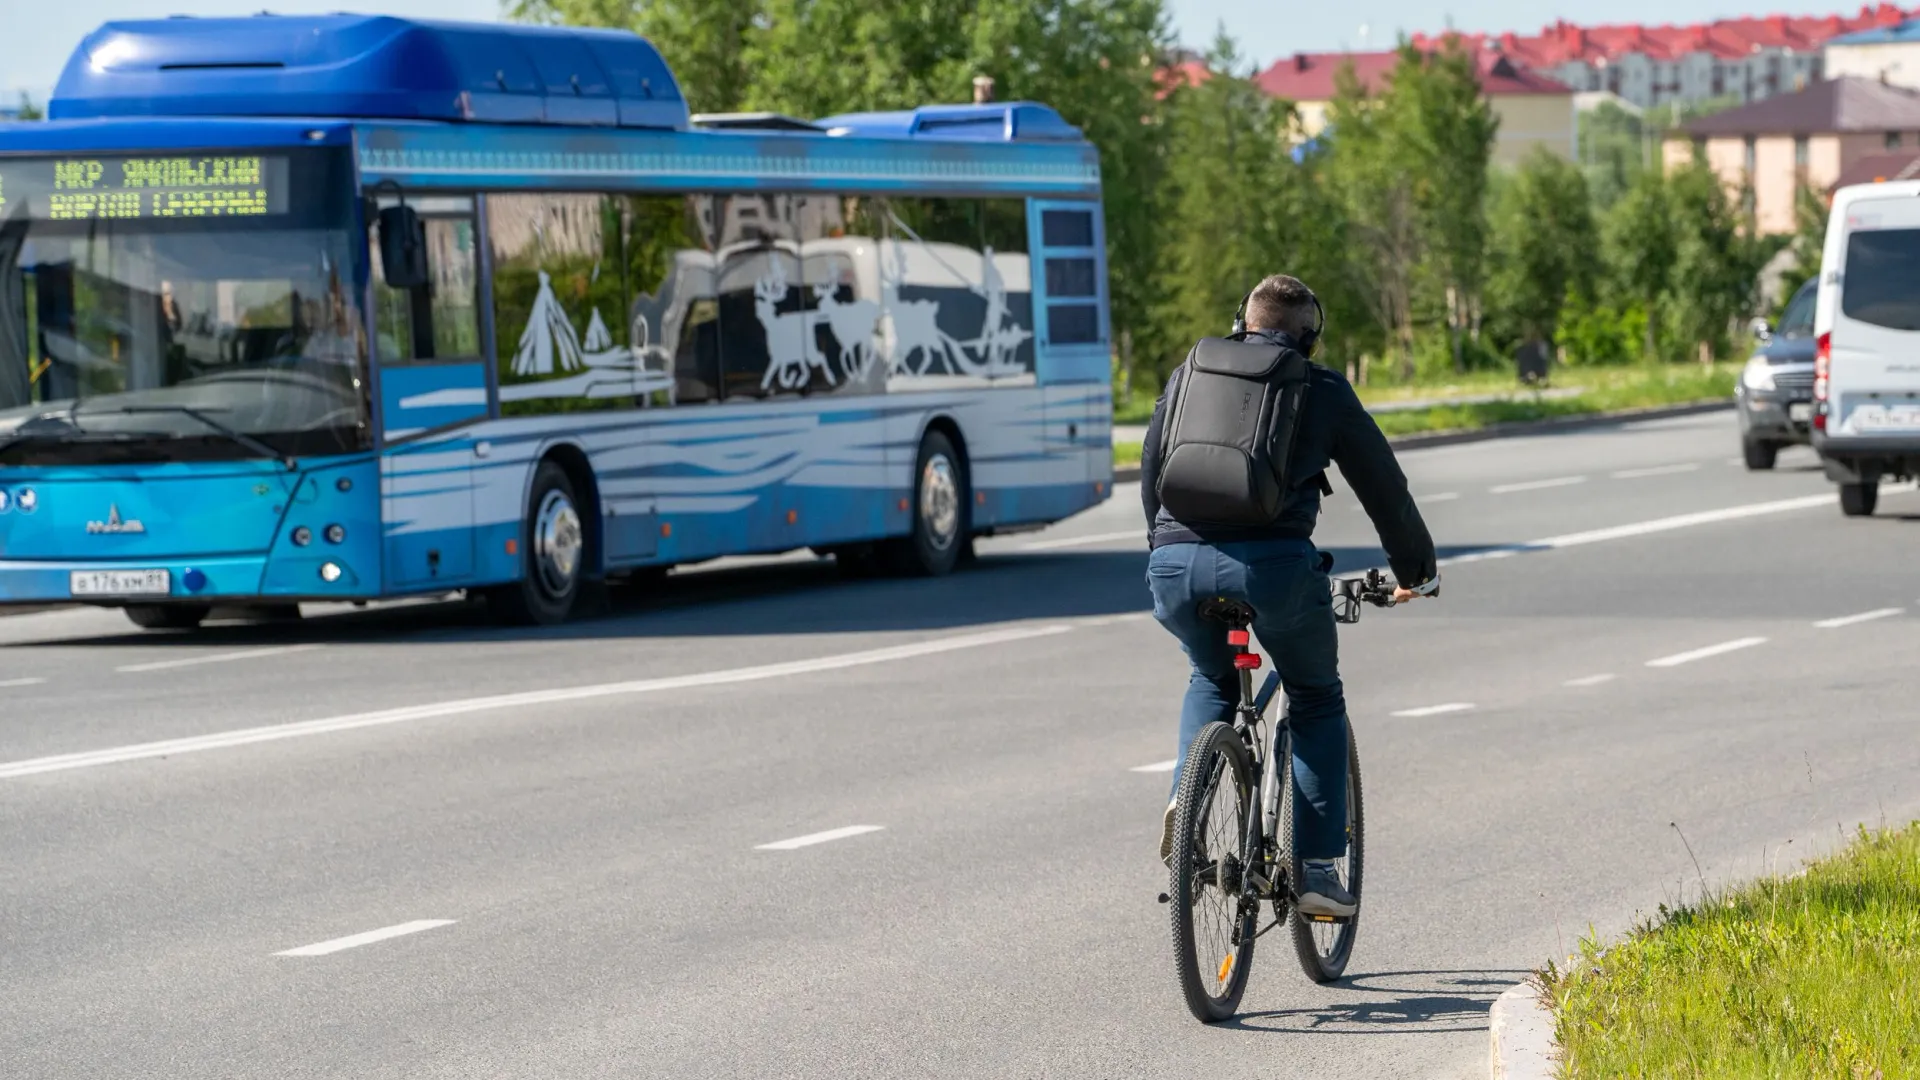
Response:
[1256, 52, 1578, 165]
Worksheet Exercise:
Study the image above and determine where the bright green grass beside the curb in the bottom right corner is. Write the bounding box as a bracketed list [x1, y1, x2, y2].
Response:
[1542, 822, 1920, 1080]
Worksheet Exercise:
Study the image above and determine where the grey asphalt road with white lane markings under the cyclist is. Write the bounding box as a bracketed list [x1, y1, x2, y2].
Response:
[0, 413, 1920, 1080]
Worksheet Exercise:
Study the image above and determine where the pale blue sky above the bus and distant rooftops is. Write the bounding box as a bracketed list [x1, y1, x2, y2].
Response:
[0, 0, 1914, 104]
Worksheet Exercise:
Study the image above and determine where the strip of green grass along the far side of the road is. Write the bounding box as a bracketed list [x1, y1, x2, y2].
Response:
[1375, 363, 1740, 434]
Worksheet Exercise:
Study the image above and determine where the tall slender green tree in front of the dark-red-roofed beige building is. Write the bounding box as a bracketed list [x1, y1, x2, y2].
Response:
[1386, 38, 1500, 371]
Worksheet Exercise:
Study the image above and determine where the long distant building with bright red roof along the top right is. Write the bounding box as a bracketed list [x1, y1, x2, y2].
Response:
[1413, 4, 1920, 108]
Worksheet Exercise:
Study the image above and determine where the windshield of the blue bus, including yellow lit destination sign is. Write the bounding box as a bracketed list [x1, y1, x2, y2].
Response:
[0, 150, 371, 457]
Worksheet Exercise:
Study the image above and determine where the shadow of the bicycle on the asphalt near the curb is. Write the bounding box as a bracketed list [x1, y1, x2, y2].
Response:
[1221, 970, 1528, 1034]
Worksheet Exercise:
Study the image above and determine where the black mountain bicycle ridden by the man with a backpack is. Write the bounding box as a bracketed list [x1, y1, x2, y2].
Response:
[1160, 571, 1394, 1022]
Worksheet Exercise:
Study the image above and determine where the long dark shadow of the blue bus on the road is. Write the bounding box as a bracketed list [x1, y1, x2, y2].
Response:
[10, 544, 1478, 648]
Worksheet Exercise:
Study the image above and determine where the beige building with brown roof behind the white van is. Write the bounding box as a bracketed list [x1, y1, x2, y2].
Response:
[1663, 77, 1920, 233]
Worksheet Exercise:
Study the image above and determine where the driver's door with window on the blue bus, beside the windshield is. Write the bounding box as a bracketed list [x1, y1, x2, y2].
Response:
[371, 196, 490, 590]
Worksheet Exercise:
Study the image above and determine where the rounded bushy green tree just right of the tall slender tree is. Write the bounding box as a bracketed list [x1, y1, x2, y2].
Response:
[1488, 148, 1597, 342]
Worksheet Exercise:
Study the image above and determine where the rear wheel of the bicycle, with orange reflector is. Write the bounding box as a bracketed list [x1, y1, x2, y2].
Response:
[1167, 723, 1260, 1024]
